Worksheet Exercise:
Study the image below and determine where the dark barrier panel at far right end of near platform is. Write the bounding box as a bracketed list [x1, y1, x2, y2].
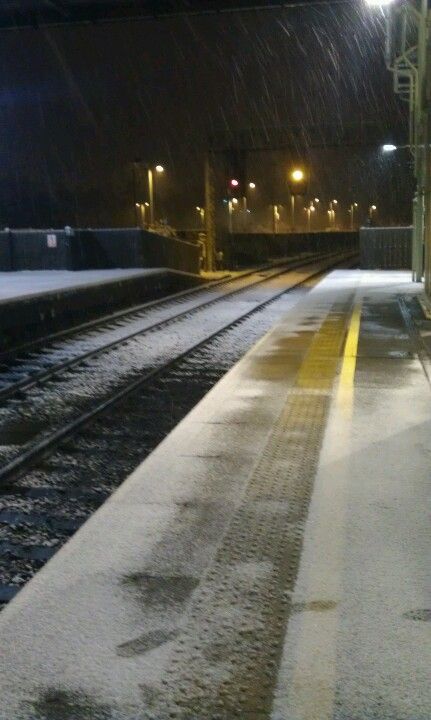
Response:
[359, 227, 413, 270]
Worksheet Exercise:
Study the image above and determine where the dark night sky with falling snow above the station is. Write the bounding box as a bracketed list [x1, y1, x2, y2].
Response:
[0, 0, 411, 226]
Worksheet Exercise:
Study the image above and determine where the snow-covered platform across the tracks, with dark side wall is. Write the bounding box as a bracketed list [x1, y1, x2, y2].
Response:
[0, 268, 202, 349]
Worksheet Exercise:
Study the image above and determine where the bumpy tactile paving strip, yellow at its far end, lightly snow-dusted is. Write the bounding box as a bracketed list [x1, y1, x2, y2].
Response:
[150, 302, 350, 720]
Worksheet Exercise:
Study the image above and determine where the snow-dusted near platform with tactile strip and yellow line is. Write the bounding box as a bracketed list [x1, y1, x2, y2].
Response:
[0, 270, 431, 720]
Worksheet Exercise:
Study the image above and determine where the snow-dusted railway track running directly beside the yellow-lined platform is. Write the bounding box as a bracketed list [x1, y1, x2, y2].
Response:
[0, 259, 356, 604]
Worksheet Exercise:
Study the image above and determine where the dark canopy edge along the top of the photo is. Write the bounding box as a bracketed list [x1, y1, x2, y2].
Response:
[0, 0, 352, 29]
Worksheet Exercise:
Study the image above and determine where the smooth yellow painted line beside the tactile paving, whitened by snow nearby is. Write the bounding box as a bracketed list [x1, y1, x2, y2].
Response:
[272, 301, 362, 720]
